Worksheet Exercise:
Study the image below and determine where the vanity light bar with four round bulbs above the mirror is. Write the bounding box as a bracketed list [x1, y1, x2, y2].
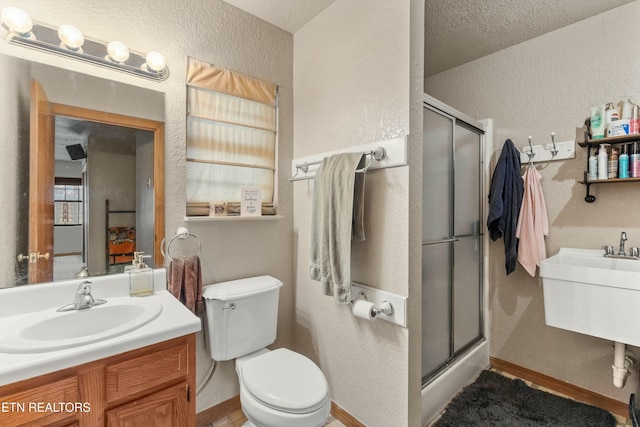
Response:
[0, 7, 169, 81]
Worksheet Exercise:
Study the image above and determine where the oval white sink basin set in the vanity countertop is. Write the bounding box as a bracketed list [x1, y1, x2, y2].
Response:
[0, 297, 162, 353]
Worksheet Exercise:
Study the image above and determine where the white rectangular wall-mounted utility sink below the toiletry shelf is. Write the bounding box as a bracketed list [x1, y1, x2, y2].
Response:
[540, 248, 640, 346]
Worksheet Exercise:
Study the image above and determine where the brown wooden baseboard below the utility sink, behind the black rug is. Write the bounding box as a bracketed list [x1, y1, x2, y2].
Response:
[489, 357, 629, 418]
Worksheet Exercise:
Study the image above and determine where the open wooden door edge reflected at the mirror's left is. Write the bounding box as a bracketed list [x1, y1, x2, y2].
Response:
[28, 80, 55, 283]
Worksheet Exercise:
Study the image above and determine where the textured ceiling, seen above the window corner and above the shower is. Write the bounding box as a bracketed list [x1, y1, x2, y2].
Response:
[220, 0, 635, 77]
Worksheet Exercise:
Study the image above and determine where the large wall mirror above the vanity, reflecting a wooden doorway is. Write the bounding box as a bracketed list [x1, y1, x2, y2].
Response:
[0, 54, 164, 287]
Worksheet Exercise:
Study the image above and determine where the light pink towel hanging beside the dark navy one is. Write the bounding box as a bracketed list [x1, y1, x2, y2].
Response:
[516, 167, 549, 277]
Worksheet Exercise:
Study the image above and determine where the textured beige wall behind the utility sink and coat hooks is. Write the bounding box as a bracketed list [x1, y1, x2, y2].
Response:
[425, 1, 640, 401]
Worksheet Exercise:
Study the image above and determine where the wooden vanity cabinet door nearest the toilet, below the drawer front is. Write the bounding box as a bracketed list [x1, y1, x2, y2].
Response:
[105, 382, 190, 427]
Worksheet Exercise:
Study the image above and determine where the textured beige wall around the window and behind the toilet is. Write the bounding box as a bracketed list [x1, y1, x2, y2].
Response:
[0, 0, 293, 411]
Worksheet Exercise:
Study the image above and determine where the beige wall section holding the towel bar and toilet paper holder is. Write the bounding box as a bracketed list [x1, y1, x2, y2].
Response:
[294, 0, 419, 426]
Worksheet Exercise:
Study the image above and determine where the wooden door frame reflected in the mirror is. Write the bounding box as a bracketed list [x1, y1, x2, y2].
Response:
[51, 102, 165, 268]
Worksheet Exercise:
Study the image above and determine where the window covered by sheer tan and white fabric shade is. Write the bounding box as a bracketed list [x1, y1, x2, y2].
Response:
[187, 59, 277, 215]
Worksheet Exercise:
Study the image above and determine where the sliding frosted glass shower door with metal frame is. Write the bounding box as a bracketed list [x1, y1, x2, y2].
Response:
[422, 104, 484, 384]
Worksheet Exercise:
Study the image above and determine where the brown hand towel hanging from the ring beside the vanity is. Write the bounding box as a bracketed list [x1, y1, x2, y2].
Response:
[169, 255, 204, 317]
